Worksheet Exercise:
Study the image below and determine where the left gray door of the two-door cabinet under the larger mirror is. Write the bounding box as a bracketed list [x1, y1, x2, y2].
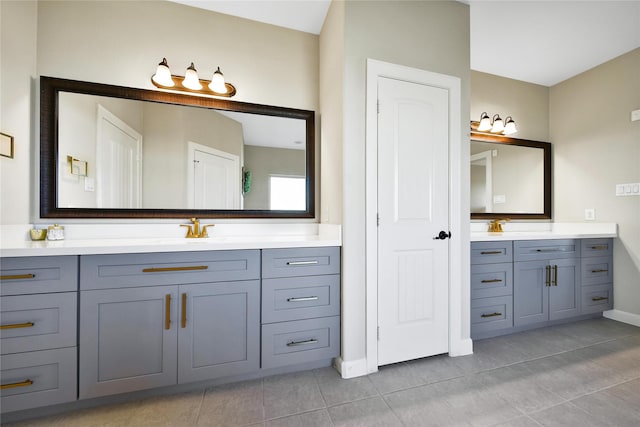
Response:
[79, 286, 178, 398]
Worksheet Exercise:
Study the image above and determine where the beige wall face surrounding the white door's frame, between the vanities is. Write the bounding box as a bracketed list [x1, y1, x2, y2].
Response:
[320, 1, 469, 363]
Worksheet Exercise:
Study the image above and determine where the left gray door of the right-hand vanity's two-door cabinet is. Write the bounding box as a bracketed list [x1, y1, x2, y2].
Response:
[513, 261, 550, 326]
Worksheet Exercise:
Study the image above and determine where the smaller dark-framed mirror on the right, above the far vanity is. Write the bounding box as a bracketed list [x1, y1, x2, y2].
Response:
[470, 132, 551, 219]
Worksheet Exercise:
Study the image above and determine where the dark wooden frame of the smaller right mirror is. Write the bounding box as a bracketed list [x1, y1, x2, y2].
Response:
[470, 131, 551, 220]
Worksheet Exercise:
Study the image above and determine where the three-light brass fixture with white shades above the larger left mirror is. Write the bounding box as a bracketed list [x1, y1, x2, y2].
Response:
[151, 58, 236, 98]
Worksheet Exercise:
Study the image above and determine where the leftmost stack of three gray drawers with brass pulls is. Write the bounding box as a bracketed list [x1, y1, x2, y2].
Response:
[0, 256, 78, 412]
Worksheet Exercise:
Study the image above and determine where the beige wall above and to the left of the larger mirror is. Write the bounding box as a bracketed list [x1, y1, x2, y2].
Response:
[0, 1, 319, 224]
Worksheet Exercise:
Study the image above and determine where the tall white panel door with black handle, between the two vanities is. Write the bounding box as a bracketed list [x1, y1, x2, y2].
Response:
[378, 77, 449, 365]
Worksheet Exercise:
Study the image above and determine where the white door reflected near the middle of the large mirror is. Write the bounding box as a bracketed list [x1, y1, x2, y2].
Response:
[188, 142, 241, 209]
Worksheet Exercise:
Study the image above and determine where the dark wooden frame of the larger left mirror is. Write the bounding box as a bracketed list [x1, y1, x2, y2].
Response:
[40, 76, 315, 219]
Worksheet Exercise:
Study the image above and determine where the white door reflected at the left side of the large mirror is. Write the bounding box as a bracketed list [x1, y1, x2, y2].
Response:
[96, 105, 142, 209]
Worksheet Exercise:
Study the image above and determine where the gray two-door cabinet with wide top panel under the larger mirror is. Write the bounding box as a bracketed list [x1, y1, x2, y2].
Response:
[79, 250, 260, 398]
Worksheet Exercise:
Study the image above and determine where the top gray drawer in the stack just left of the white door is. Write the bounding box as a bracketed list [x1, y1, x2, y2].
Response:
[262, 247, 340, 278]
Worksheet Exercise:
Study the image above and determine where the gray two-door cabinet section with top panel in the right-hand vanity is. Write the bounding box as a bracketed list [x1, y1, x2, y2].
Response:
[513, 240, 581, 327]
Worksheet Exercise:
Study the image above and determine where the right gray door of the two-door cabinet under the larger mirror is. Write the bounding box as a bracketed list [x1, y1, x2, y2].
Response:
[178, 280, 260, 383]
